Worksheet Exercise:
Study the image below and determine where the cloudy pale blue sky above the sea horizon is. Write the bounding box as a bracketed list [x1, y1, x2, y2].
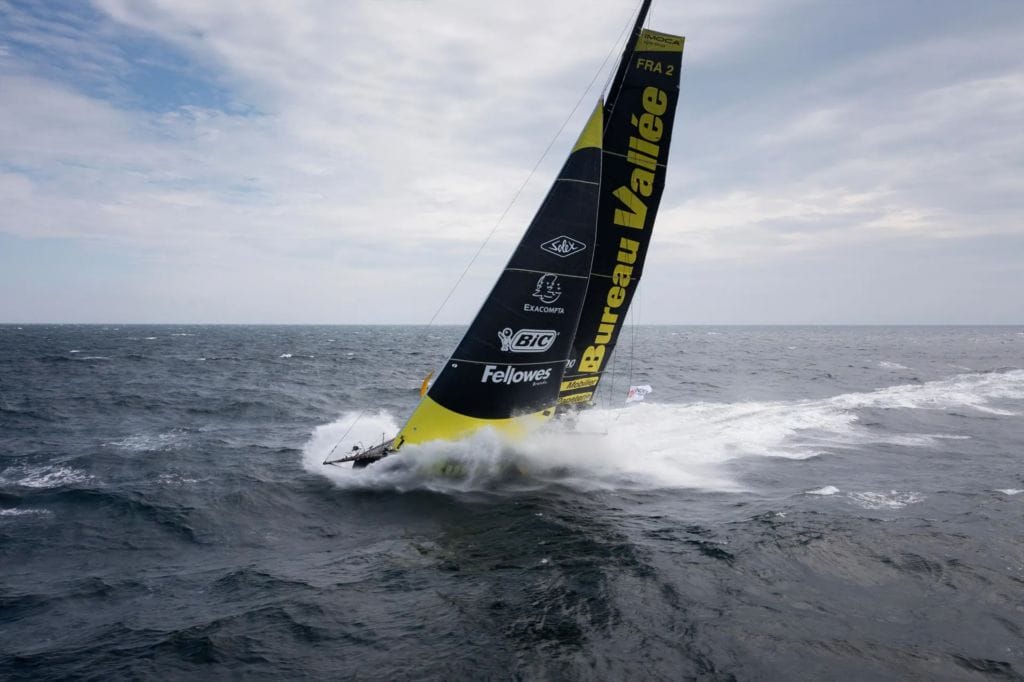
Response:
[0, 0, 1024, 325]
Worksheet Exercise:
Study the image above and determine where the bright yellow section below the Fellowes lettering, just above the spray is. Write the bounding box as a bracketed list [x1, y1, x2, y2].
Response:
[394, 395, 555, 450]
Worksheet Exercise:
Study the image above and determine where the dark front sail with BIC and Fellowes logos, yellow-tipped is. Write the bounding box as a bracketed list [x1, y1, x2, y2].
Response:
[393, 102, 603, 450]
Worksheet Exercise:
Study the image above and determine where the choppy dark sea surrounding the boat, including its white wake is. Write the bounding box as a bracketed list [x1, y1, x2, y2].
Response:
[0, 326, 1024, 680]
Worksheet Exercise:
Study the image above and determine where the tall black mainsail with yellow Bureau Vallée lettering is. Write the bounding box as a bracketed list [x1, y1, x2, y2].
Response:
[558, 23, 683, 404]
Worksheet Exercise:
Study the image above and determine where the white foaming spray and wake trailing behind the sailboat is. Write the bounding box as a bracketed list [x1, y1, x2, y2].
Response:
[303, 370, 1024, 492]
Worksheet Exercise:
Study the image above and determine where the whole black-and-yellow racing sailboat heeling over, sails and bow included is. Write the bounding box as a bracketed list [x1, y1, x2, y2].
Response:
[325, 0, 684, 468]
